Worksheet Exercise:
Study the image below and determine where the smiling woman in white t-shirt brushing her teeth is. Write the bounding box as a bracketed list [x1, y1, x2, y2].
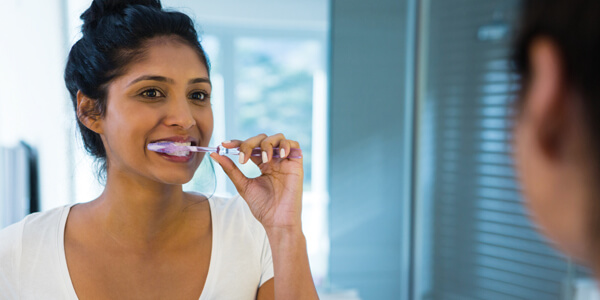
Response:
[0, 0, 317, 299]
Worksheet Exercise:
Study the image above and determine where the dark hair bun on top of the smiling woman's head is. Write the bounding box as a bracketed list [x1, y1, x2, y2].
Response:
[81, 0, 162, 34]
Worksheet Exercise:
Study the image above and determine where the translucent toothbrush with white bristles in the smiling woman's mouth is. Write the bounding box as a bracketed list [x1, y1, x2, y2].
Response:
[148, 142, 302, 158]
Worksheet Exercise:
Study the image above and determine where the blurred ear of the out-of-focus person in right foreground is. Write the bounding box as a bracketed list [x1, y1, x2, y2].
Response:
[525, 38, 574, 158]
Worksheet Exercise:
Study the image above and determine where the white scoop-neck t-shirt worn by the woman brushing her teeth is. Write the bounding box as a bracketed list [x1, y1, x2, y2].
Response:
[0, 196, 273, 300]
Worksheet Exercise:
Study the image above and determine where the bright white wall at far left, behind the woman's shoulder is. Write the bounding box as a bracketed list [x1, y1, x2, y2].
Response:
[0, 0, 73, 210]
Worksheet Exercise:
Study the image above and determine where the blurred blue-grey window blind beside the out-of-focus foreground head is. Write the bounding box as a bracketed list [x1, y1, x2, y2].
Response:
[420, 0, 588, 300]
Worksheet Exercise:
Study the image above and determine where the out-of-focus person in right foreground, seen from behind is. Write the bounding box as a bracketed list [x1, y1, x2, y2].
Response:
[515, 0, 600, 282]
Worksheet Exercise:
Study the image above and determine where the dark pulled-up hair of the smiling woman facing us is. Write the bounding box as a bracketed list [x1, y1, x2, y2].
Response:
[65, 0, 210, 178]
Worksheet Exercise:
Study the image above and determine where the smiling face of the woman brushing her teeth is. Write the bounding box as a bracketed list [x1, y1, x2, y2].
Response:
[101, 37, 213, 184]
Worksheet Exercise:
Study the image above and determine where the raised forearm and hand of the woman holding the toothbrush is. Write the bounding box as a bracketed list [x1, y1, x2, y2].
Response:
[211, 134, 318, 300]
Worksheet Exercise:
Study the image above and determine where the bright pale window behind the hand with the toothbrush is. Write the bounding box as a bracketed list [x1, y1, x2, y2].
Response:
[185, 32, 329, 282]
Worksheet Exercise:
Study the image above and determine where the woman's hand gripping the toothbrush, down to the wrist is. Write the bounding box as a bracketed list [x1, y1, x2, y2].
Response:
[210, 133, 304, 230]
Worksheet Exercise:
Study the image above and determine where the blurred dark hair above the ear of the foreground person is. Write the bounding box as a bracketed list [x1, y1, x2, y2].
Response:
[513, 0, 600, 141]
